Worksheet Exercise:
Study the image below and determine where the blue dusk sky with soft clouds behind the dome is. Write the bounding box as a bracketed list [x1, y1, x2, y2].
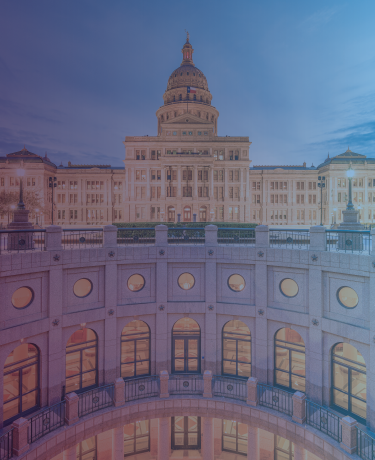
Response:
[0, 0, 375, 166]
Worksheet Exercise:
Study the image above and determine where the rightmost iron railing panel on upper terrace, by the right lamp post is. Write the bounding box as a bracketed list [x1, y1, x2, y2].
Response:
[326, 230, 372, 254]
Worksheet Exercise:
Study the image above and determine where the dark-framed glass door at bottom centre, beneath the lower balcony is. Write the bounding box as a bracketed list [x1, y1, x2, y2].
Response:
[171, 416, 201, 450]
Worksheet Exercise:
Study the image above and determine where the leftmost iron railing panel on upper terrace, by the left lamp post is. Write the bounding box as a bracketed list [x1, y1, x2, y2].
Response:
[0, 229, 46, 254]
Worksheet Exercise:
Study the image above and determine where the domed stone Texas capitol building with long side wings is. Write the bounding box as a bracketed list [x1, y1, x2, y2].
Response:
[0, 38, 375, 226]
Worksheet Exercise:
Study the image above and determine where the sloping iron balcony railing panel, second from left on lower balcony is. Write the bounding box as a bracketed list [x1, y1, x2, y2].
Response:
[28, 401, 65, 444]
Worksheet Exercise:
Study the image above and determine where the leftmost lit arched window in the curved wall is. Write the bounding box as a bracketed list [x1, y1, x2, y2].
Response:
[3, 343, 39, 425]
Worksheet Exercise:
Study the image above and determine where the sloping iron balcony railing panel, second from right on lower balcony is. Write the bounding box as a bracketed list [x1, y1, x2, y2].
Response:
[306, 401, 341, 442]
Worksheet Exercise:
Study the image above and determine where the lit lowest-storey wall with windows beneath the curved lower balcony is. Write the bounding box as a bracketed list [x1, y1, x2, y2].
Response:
[52, 416, 319, 460]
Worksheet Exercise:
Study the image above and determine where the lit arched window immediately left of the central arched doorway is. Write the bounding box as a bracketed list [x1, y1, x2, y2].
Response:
[121, 320, 151, 379]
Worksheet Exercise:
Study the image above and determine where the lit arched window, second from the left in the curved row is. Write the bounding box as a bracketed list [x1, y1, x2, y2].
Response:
[65, 328, 98, 393]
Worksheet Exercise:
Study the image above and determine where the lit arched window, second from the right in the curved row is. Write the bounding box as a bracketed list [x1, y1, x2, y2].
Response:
[274, 327, 306, 392]
